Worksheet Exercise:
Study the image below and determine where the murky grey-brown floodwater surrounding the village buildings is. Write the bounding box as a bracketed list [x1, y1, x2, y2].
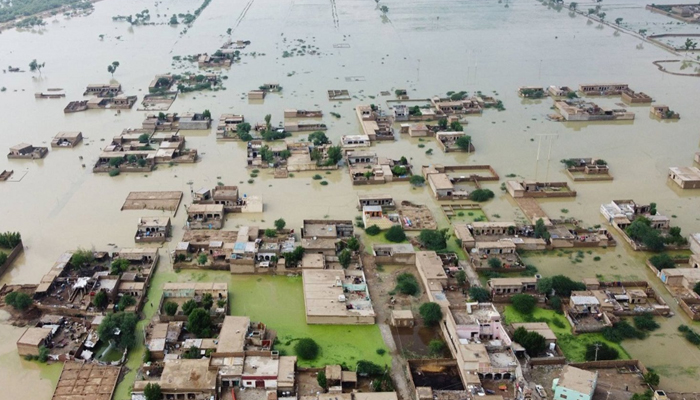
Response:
[0, 0, 700, 394]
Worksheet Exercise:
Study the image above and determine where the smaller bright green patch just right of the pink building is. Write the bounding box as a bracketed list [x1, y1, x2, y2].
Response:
[503, 305, 630, 362]
